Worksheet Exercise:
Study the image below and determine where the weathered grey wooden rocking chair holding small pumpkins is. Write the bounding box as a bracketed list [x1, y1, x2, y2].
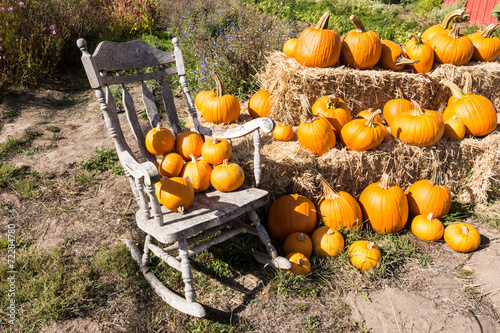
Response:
[77, 38, 291, 317]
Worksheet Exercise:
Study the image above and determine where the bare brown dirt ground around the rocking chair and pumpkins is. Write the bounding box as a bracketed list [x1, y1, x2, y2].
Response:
[0, 79, 500, 333]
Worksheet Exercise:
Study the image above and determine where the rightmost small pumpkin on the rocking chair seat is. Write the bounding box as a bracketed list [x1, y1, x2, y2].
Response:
[210, 159, 245, 192]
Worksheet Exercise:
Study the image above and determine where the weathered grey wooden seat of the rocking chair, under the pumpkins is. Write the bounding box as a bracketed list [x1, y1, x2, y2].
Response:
[136, 185, 267, 244]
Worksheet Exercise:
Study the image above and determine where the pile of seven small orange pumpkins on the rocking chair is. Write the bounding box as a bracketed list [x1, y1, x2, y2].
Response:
[145, 123, 245, 214]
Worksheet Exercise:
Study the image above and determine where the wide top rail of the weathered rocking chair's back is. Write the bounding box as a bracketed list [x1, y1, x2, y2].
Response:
[93, 40, 175, 71]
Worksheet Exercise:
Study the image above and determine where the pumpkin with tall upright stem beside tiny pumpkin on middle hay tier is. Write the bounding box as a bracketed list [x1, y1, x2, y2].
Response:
[297, 95, 337, 156]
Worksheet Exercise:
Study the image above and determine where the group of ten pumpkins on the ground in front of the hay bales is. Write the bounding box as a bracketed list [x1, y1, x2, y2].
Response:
[268, 171, 481, 275]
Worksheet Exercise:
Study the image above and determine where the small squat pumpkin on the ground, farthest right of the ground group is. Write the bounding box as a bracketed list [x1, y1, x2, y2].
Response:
[444, 222, 481, 252]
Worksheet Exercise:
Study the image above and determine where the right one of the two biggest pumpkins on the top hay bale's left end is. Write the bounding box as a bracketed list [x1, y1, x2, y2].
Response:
[340, 15, 382, 69]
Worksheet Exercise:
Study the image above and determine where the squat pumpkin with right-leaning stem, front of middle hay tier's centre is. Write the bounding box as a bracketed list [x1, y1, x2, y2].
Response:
[340, 110, 387, 151]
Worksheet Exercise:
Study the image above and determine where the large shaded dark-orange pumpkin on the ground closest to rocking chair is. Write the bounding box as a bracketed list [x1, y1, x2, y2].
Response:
[268, 194, 316, 240]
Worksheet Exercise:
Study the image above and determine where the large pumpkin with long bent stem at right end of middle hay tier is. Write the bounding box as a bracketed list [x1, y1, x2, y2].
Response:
[440, 80, 497, 136]
